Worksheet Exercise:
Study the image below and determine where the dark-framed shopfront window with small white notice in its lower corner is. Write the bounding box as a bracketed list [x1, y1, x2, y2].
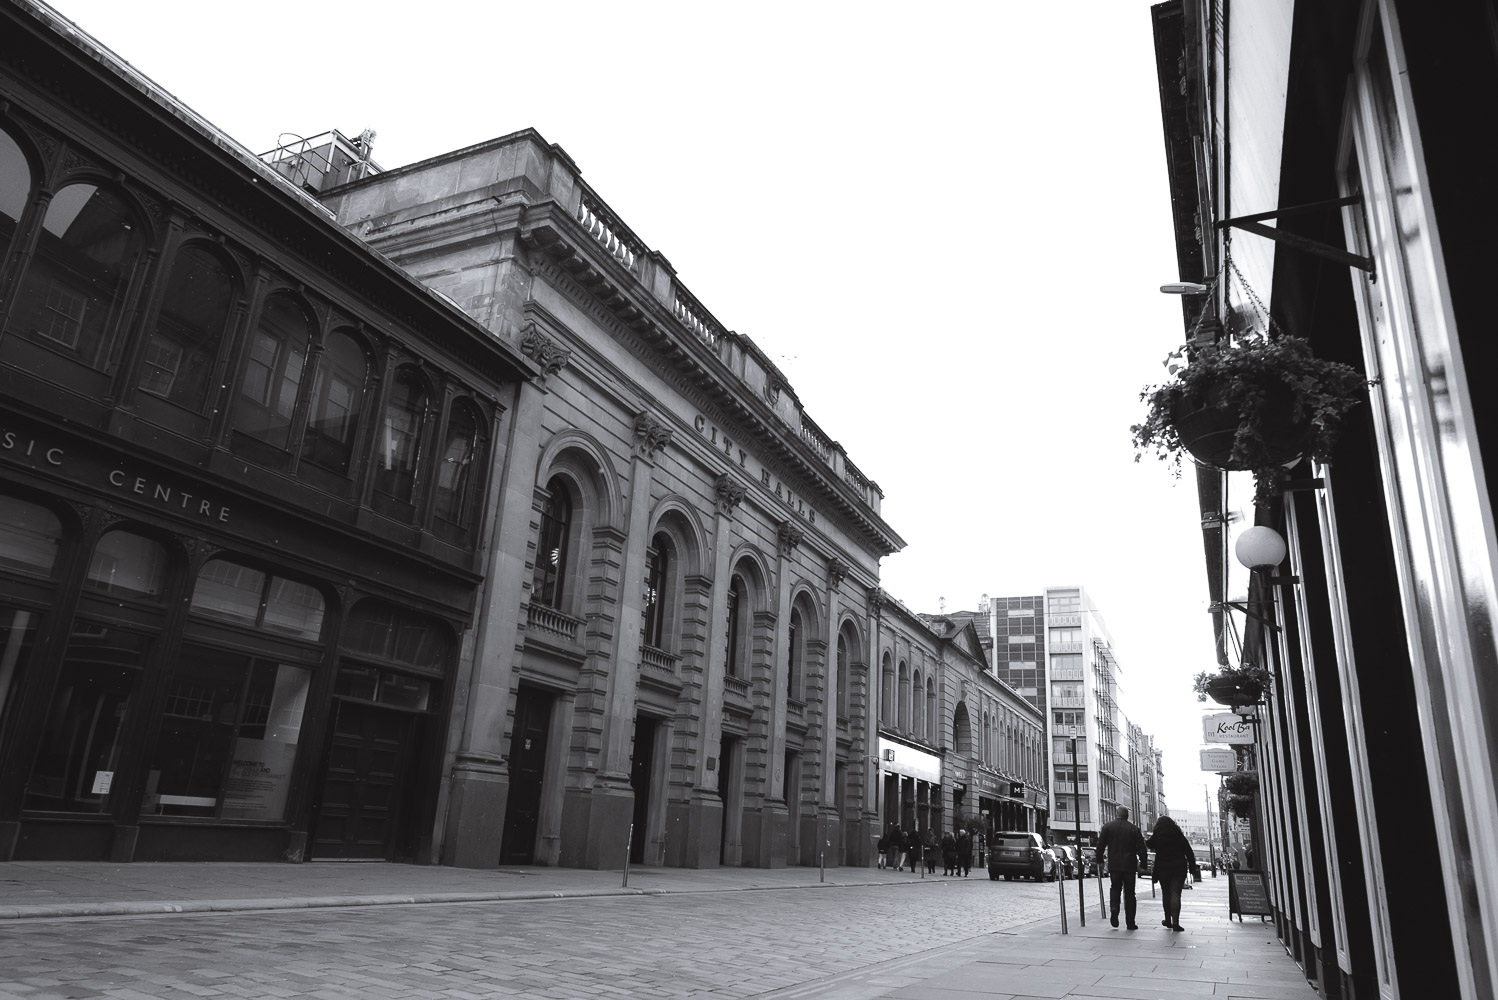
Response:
[24, 623, 150, 813]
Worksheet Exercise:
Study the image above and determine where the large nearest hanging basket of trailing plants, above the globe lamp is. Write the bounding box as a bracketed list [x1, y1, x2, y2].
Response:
[1129, 334, 1366, 475]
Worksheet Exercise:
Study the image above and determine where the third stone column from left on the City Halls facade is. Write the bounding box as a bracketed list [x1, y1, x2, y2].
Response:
[683, 473, 748, 868]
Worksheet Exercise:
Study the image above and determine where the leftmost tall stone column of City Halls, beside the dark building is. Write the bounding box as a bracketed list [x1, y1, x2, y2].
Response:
[440, 347, 569, 868]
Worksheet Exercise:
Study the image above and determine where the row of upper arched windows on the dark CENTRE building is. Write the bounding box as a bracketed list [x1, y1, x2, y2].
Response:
[0, 129, 488, 543]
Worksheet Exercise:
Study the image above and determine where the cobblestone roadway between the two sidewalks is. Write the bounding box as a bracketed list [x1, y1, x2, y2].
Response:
[0, 877, 1056, 1000]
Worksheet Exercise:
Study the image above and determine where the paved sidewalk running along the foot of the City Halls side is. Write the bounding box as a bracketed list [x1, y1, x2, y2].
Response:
[0, 861, 987, 919]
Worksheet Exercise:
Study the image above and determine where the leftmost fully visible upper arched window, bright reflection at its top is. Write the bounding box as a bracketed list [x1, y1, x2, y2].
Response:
[7, 182, 141, 368]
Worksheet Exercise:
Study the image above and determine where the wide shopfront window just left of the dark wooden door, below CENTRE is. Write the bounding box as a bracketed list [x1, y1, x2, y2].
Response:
[141, 647, 312, 822]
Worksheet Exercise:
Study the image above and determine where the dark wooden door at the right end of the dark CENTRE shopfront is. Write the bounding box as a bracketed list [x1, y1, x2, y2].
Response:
[312, 702, 415, 858]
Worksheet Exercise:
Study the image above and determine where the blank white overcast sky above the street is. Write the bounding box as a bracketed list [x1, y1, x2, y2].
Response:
[43, 0, 1216, 811]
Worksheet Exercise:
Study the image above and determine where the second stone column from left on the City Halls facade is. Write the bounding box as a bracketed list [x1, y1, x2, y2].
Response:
[586, 413, 671, 868]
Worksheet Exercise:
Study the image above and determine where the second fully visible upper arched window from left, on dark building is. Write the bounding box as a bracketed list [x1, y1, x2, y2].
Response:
[139, 246, 234, 413]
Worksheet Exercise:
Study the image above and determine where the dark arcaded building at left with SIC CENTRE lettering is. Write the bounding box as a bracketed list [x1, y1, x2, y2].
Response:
[0, 3, 536, 861]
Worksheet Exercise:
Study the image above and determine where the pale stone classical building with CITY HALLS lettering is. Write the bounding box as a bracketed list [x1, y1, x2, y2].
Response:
[314, 130, 903, 867]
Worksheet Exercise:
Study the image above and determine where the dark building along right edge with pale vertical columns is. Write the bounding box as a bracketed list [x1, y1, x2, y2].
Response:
[1149, 0, 1498, 1000]
